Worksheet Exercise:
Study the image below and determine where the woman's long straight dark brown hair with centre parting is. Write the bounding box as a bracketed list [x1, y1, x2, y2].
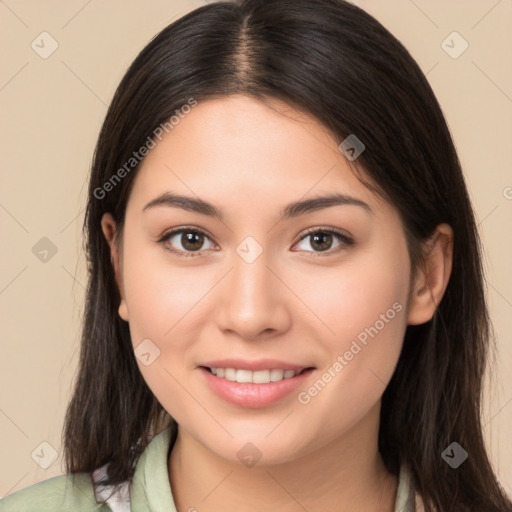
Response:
[63, 0, 512, 512]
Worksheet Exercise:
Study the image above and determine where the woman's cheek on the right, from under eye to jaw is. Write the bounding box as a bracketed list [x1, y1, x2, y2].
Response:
[294, 244, 409, 431]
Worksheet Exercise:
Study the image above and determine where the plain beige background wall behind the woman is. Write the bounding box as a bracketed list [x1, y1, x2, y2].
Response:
[0, 0, 512, 496]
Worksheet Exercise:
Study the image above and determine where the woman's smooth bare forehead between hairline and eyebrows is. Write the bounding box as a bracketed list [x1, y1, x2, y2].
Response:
[131, 95, 386, 215]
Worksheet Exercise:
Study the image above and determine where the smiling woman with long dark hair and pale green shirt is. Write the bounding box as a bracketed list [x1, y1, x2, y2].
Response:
[0, 0, 512, 512]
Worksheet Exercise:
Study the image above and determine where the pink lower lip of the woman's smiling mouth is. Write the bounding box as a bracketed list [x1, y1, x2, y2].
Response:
[199, 367, 314, 409]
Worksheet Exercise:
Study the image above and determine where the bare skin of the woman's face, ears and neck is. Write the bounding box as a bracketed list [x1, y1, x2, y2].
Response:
[102, 95, 453, 512]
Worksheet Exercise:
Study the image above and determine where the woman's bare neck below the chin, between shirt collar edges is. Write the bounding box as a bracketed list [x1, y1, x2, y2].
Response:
[169, 404, 398, 512]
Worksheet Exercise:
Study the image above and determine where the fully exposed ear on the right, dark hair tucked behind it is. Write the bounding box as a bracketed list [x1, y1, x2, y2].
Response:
[407, 224, 453, 325]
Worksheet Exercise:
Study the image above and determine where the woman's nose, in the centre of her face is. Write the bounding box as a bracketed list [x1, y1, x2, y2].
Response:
[216, 247, 293, 340]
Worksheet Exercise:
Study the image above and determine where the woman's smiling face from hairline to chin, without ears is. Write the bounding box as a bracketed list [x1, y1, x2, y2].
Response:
[104, 96, 410, 464]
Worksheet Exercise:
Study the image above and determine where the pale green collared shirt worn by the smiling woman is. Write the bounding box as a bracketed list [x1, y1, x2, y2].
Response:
[0, 428, 418, 512]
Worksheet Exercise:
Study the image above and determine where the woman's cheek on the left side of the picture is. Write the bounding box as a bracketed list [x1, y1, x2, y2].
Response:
[119, 237, 203, 419]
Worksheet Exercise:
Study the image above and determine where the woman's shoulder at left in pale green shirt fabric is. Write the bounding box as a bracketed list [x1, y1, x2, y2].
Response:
[0, 473, 111, 512]
